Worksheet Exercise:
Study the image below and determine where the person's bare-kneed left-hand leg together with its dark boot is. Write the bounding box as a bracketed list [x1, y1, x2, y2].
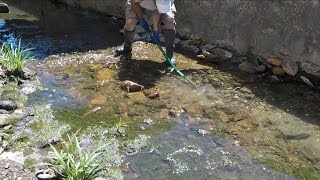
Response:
[116, 0, 138, 55]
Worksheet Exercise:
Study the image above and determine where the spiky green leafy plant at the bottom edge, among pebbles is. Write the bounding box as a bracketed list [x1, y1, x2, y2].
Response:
[51, 134, 103, 180]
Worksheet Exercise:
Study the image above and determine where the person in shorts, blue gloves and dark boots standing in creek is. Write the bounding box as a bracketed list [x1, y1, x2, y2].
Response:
[116, 0, 176, 63]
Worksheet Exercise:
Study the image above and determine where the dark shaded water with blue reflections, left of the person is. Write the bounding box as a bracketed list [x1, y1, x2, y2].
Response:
[0, 0, 122, 58]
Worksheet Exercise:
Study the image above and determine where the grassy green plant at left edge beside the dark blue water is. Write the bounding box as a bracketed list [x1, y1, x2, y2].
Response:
[0, 39, 32, 76]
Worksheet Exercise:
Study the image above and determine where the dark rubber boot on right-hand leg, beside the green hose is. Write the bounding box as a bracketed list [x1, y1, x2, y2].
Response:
[163, 29, 176, 64]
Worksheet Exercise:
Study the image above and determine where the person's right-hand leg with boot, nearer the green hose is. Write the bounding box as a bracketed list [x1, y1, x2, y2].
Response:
[161, 12, 176, 63]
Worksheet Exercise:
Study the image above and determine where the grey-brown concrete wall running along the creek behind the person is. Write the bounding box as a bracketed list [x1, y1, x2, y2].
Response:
[54, 0, 320, 66]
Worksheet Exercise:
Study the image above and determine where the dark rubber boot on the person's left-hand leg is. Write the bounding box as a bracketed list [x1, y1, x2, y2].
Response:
[116, 30, 135, 56]
